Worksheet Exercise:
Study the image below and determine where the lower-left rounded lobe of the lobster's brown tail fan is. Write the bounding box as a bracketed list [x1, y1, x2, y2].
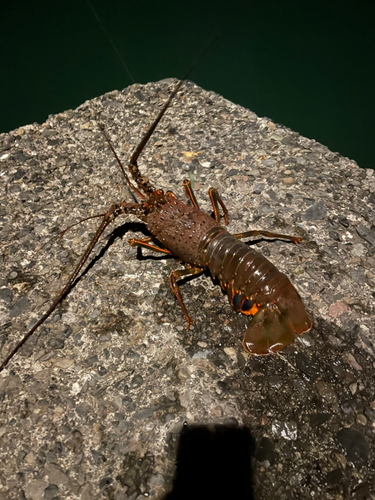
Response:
[243, 304, 295, 356]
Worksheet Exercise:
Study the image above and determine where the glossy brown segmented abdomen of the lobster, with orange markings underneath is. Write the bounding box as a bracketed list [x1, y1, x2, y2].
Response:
[200, 228, 290, 315]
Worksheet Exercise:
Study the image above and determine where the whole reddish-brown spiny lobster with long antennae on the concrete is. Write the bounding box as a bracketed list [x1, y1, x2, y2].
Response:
[0, 80, 312, 370]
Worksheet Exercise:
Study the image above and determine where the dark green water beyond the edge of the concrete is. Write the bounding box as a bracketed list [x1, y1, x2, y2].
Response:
[0, 0, 375, 168]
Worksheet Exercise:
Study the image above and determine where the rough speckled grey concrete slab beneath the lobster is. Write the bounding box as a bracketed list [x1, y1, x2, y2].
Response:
[0, 80, 375, 500]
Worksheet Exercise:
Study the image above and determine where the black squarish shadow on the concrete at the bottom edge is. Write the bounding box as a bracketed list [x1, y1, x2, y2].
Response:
[163, 424, 255, 500]
